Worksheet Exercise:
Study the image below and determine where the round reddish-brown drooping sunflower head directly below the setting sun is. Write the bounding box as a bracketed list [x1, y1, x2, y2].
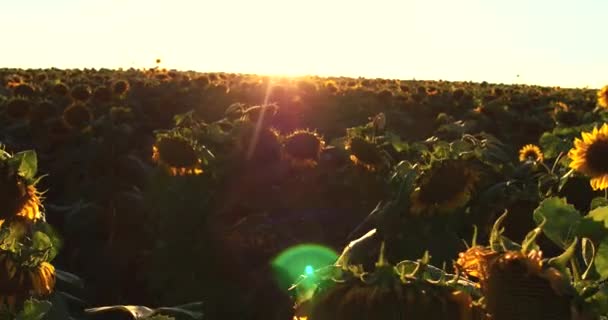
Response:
[283, 130, 325, 167]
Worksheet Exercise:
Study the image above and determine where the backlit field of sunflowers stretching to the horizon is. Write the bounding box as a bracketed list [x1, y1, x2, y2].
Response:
[0, 68, 608, 320]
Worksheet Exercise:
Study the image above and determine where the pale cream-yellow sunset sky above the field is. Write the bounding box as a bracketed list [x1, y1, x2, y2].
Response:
[0, 0, 608, 88]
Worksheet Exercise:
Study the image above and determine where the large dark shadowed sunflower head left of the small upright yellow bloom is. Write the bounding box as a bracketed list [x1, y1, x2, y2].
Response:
[410, 160, 479, 215]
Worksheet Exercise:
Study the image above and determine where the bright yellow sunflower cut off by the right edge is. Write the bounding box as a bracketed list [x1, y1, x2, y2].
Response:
[568, 123, 608, 190]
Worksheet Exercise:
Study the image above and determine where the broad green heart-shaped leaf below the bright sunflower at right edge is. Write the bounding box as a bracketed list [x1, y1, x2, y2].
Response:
[533, 197, 582, 249]
